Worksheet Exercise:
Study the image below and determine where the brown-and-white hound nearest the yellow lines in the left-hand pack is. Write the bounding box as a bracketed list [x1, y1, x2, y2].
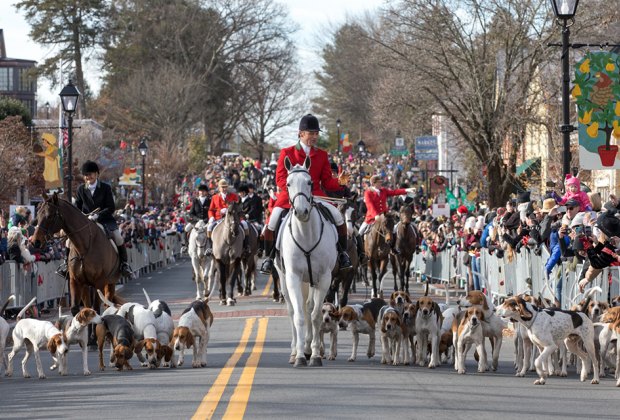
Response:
[172, 300, 213, 368]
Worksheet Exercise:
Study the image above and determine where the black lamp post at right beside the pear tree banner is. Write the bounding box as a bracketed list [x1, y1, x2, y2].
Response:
[551, 0, 579, 178]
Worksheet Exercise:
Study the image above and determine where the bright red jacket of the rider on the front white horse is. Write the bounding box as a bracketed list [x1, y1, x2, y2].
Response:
[275, 142, 342, 209]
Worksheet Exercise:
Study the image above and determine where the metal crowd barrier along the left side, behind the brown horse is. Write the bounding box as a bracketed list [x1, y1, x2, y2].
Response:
[0, 234, 181, 307]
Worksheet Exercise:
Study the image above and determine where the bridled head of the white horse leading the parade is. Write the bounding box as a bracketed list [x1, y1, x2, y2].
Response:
[284, 157, 314, 222]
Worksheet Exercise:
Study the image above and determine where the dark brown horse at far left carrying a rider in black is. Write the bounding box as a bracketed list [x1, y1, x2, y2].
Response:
[32, 193, 124, 312]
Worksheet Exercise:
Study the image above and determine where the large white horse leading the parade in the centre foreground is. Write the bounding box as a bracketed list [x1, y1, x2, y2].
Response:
[275, 157, 338, 367]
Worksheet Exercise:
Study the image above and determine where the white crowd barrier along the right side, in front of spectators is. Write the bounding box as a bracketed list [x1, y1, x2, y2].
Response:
[411, 247, 620, 309]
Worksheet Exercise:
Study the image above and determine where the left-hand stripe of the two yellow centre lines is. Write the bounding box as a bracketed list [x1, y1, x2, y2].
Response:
[192, 318, 256, 419]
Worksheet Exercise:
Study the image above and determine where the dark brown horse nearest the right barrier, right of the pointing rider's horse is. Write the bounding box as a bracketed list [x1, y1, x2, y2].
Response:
[390, 206, 419, 293]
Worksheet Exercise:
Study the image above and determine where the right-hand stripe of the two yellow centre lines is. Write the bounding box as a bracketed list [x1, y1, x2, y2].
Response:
[222, 318, 269, 420]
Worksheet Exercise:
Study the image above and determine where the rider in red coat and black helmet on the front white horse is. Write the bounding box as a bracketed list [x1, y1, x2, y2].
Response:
[260, 114, 351, 274]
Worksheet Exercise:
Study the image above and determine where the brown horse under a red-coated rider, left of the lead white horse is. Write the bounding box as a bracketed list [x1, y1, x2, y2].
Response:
[211, 203, 243, 306]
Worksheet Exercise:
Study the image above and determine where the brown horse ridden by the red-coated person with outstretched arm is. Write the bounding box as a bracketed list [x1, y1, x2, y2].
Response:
[364, 214, 394, 298]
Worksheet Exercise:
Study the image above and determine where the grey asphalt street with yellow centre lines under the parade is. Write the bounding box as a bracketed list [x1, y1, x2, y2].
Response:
[0, 261, 620, 419]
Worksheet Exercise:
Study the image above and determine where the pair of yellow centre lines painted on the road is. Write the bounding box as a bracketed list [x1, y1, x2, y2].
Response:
[192, 318, 269, 419]
